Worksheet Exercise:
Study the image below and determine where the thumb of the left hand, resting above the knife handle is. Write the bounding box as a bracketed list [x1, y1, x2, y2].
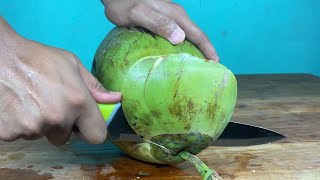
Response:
[78, 62, 121, 103]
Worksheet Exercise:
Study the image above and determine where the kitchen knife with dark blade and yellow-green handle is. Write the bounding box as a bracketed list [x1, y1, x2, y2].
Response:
[98, 103, 285, 146]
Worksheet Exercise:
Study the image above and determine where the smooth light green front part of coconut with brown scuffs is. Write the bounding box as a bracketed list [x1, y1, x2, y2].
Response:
[122, 53, 236, 163]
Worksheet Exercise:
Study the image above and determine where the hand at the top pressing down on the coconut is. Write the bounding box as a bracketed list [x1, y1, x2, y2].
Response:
[102, 0, 219, 62]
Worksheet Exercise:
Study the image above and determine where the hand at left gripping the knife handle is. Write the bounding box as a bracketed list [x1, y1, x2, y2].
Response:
[0, 17, 121, 145]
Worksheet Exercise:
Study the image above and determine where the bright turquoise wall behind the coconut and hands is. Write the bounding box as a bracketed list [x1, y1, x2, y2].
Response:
[0, 0, 320, 76]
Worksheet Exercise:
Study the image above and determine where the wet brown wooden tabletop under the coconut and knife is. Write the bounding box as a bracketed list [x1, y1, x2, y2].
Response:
[0, 74, 320, 180]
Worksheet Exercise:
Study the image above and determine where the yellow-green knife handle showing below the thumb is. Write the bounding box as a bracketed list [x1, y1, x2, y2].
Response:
[97, 102, 121, 126]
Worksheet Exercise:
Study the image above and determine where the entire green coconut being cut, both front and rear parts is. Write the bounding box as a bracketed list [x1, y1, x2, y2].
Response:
[92, 27, 237, 164]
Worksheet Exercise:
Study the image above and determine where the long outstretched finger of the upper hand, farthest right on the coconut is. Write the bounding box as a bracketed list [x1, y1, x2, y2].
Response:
[144, 0, 219, 62]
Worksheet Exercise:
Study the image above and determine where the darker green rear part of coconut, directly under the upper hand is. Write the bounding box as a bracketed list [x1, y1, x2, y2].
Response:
[91, 27, 205, 91]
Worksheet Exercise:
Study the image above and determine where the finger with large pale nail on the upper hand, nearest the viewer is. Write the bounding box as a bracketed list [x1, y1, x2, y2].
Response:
[129, 3, 185, 44]
